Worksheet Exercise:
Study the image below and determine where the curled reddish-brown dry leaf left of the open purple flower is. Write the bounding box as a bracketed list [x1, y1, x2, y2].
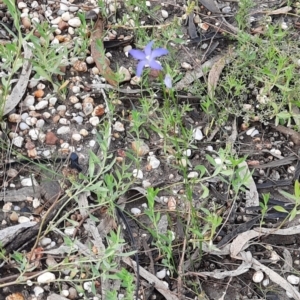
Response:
[91, 16, 118, 86]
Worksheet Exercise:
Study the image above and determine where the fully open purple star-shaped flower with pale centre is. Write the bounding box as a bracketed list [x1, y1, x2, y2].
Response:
[129, 41, 169, 77]
